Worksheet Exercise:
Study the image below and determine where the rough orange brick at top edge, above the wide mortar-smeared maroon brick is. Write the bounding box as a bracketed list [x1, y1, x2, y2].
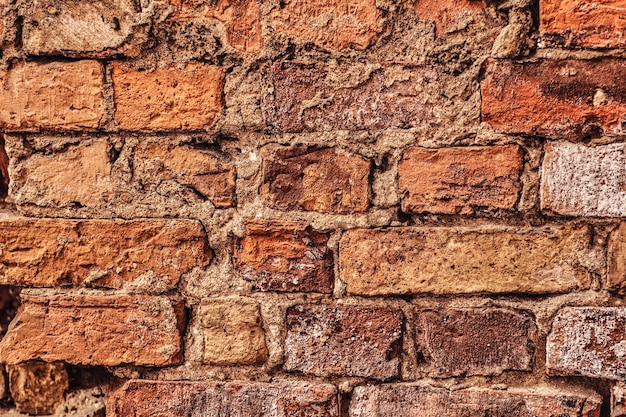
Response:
[269, 0, 384, 50]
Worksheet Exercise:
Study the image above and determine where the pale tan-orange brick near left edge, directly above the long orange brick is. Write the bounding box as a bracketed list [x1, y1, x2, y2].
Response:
[12, 139, 115, 208]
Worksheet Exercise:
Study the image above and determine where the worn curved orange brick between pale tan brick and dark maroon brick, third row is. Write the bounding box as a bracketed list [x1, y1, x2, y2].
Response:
[135, 143, 237, 208]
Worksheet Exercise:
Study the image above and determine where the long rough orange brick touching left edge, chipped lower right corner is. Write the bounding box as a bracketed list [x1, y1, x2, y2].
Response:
[0, 217, 211, 292]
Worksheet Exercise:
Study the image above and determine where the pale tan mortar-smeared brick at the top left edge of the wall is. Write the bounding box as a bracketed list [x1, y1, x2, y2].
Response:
[23, 0, 150, 57]
